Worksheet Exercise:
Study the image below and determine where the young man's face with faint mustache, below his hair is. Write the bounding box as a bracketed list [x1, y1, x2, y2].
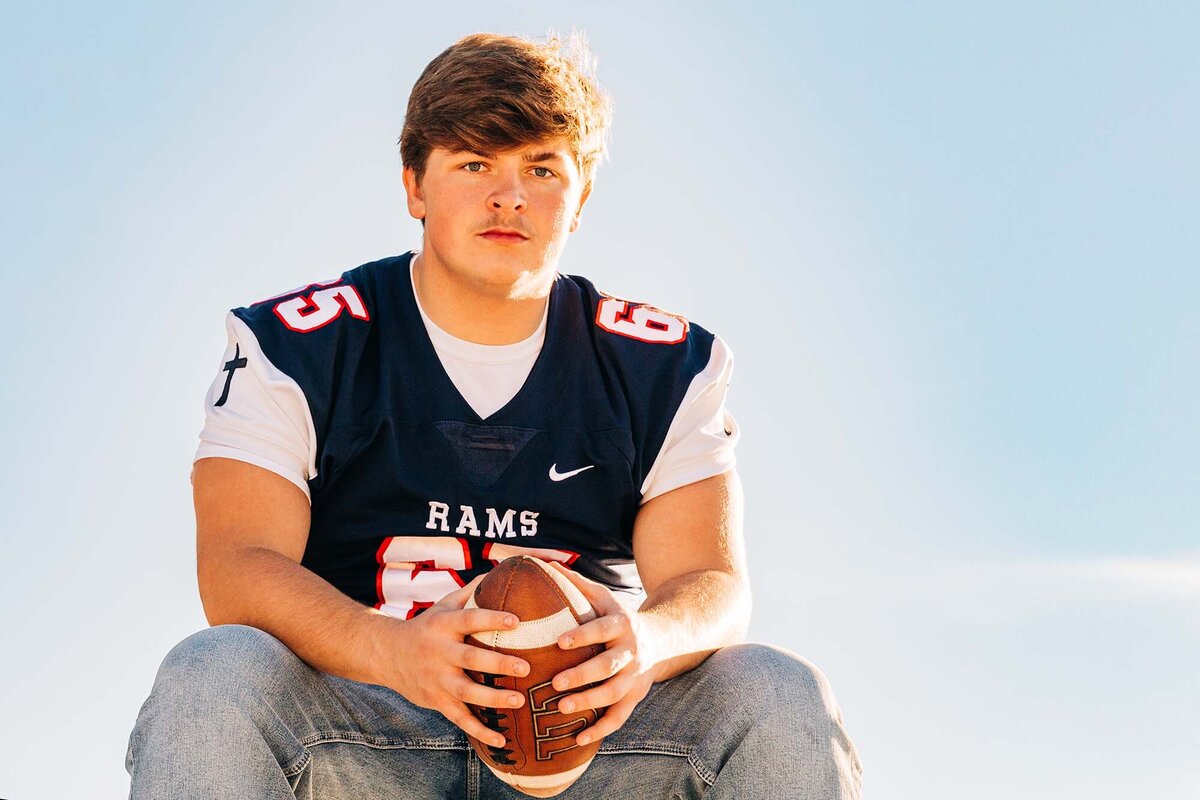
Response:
[404, 138, 590, 299]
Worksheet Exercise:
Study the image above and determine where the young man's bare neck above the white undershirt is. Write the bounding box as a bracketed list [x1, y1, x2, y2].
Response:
[413, 251, 554, 344]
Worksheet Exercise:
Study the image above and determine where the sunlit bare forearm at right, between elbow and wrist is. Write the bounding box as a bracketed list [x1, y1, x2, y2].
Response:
[637, 570, 750, 681]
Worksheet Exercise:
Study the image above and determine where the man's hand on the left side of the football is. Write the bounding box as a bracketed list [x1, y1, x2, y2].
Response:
[385, 576, 529, 747]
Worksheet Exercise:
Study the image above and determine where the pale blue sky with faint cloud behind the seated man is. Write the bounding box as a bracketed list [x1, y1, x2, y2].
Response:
[0, 1, 1200, 800]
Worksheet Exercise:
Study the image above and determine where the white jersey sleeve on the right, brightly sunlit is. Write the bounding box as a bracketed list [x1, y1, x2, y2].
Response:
[642, 337, 742, 504]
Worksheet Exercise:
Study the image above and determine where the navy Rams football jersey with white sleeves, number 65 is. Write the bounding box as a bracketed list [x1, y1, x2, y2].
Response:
[197, 253, 737, 618]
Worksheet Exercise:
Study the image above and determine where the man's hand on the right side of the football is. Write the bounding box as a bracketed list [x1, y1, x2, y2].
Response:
[553, 563, 658, 745]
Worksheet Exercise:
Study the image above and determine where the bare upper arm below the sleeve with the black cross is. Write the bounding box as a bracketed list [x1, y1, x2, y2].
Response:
[192, 458, 310, 575]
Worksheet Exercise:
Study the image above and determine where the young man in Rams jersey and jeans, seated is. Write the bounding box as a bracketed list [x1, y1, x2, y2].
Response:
[127, 35, 859, 799]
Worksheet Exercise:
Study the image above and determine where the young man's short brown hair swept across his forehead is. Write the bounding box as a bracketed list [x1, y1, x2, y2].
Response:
[400, 31, 612, 190]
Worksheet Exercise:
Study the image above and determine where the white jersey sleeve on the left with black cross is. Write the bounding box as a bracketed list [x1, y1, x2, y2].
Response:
[194, 312, 317, 500]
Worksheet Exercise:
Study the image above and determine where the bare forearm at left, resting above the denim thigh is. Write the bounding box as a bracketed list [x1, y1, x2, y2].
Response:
[199, 547, 404, 684]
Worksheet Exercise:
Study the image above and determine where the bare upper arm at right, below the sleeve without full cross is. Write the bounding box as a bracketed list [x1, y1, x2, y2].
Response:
[634, 469, 746, 594]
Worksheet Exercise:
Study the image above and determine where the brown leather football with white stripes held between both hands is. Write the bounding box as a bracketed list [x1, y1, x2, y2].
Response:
[467, 555, 604, 798]
